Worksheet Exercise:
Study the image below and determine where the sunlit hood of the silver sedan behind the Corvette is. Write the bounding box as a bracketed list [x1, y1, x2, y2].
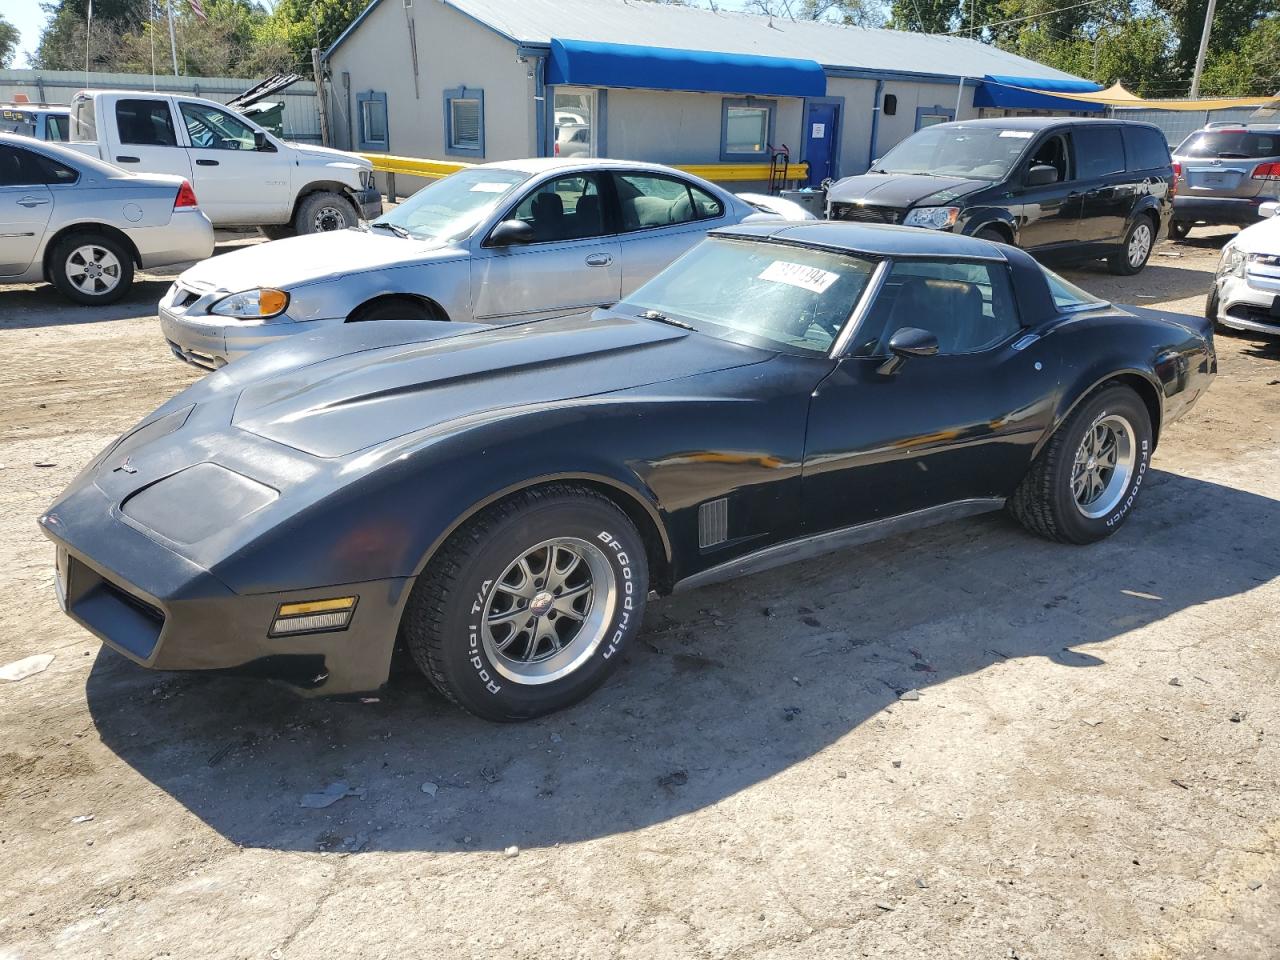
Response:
[178, 230, 466, 293]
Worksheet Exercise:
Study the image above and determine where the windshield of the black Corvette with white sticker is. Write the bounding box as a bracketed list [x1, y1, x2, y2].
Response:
[618, 237, 876, 353]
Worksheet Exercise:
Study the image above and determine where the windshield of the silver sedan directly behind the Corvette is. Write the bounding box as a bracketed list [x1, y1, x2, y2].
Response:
[374, 166, 529, 241]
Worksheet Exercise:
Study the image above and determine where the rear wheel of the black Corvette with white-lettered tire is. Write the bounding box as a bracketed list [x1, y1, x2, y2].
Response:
[1009, 384, 1152, 544]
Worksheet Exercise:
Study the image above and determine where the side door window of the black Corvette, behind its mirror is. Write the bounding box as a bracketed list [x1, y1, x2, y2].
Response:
[852, 260, 1021, 357]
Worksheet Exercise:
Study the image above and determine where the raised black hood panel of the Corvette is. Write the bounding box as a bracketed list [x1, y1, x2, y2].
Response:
[233, 311, 772, 457]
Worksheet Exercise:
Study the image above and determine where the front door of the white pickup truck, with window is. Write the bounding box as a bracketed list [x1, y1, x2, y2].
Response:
[177, 100, 293, 224]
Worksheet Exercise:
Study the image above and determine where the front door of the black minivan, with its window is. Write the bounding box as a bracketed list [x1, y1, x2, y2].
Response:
[1001, 129, 1083, 250]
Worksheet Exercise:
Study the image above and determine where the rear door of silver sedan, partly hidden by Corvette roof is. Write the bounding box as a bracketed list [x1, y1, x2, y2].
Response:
[612, 170, 724, 297]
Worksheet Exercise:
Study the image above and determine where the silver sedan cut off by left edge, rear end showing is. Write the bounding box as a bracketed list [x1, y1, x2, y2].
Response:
[0, 133, 214, 305]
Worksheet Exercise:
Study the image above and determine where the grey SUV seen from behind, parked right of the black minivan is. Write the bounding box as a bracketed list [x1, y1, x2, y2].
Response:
[1169, 123, 1280, 239]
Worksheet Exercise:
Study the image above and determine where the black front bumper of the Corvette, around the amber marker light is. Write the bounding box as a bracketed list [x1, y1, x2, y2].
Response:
[40, 481, 412, 696]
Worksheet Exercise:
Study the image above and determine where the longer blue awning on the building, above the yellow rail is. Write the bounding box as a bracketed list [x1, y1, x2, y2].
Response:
[547, 40, 827, 97]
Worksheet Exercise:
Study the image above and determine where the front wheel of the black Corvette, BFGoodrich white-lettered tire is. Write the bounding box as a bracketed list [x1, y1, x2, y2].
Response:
[401, 484, 649, 721]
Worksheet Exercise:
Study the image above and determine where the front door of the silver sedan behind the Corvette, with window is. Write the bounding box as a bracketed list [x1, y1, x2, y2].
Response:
[471, 173, 622, 321]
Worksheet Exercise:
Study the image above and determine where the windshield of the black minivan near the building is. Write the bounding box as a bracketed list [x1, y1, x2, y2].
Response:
[872, 123, 1032, 180]
